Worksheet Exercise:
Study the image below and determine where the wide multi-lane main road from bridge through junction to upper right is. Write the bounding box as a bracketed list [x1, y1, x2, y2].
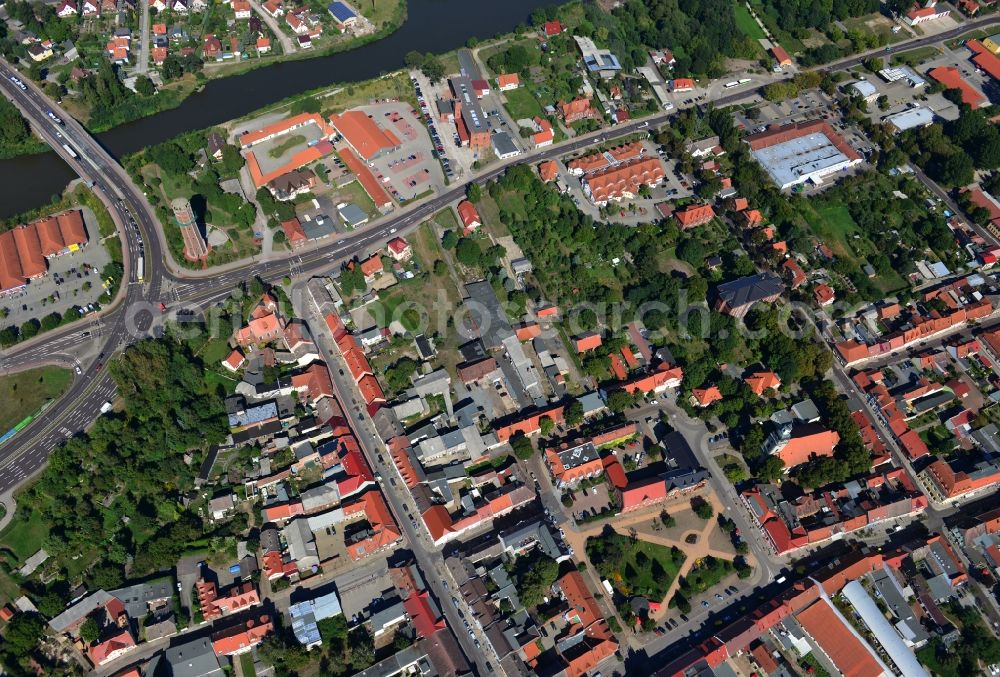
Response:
[0, 17, 1000, 494]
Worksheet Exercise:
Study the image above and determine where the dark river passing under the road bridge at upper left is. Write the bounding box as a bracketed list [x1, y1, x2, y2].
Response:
[0, 0, 556, 218]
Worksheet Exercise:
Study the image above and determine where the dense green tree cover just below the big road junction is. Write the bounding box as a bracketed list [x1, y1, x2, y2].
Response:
[18, 339, 227, 585]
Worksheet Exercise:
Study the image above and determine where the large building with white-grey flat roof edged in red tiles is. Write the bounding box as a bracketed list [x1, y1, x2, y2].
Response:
[747, 120, 862, 190]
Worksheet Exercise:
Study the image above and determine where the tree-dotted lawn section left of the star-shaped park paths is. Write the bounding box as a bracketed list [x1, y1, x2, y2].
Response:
[587, 527, 684, 601]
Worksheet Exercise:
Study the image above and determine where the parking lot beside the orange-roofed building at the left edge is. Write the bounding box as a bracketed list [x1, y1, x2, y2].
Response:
[0, 207, 111, 326]
